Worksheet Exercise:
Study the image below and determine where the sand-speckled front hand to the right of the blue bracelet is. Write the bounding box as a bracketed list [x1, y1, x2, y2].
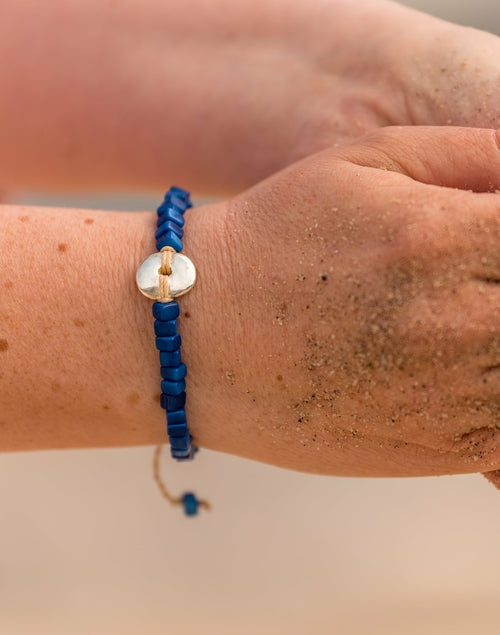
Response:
[183, 127, 500, 476]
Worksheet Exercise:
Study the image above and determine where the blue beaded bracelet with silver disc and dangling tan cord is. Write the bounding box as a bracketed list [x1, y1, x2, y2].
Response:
[137, 187, 209, 516]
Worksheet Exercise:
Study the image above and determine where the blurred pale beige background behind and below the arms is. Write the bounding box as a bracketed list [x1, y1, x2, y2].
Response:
[0, 0, 500, 635]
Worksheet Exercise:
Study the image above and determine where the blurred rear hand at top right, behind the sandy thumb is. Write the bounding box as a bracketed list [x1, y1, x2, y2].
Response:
[250, 0, 500, 183]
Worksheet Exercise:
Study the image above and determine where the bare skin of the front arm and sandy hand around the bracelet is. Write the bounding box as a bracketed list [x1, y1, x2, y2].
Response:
[0, 127, 500, 484]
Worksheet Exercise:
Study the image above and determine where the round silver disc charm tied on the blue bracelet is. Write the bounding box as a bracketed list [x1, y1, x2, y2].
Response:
[136, 251, 196, 300]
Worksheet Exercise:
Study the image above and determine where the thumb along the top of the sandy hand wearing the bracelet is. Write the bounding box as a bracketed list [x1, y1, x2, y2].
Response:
[337, 126, 500, 192]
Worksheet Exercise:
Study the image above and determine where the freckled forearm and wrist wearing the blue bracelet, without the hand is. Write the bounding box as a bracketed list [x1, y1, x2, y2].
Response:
[0, 201, 229, 451]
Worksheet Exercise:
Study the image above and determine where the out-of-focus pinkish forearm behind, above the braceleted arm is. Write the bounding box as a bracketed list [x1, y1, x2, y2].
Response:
[0, 0, 438, 193]
